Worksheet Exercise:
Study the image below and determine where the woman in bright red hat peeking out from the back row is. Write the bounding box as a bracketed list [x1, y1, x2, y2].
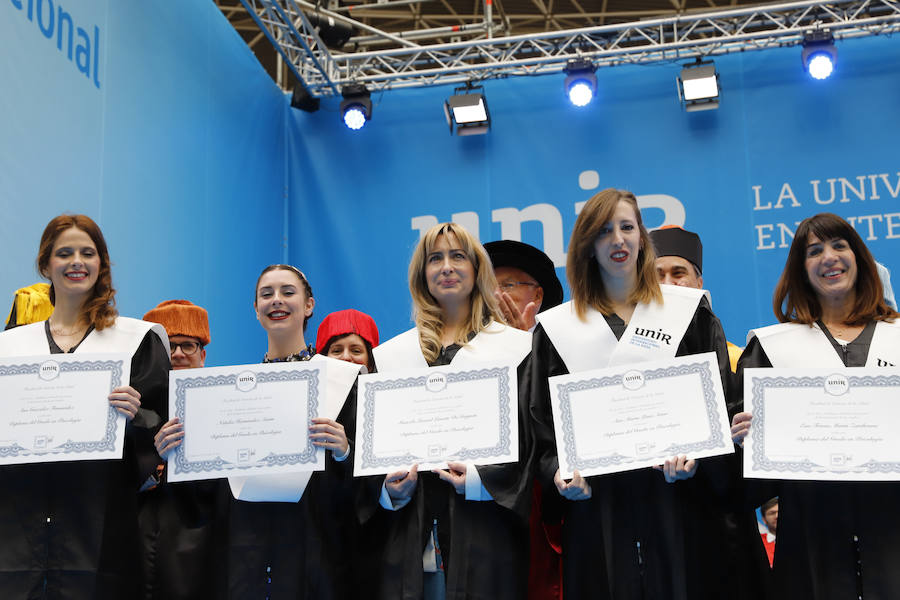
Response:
[316, 308, 378, 373]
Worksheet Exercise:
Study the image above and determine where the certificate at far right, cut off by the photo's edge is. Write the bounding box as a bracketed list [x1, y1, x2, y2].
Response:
[744, 367, 900, 481]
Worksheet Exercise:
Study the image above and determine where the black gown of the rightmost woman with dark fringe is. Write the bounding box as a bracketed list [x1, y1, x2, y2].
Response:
[738, 323, 900, 600]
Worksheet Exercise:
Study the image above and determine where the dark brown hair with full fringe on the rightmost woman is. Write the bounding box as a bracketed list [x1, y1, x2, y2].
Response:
[772, 213, 900, 325]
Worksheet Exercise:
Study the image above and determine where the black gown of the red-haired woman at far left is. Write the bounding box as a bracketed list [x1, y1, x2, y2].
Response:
[0, 330, 169, 600]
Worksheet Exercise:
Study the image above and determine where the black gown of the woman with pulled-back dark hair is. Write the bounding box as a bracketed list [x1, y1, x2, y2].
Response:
[216, 366, 356, 600]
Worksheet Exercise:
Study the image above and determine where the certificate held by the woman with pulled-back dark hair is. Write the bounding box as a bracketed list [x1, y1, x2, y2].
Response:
[168, 362, 326, 481]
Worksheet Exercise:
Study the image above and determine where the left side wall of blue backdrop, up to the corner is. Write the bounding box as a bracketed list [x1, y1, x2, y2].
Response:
[0, 0, 286, 364]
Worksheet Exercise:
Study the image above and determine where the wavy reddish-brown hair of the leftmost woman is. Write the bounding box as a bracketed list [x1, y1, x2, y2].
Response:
[37, 215, 119, 331]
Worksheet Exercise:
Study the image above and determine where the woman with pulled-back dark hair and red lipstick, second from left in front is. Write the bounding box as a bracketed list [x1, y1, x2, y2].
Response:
[156, 265, 356, 600]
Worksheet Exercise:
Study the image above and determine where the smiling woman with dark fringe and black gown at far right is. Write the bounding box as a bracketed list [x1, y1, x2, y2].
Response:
[731, 213, 900, 600]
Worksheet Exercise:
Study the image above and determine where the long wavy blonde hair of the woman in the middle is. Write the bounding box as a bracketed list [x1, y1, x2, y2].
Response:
[409, 223, 504, 363]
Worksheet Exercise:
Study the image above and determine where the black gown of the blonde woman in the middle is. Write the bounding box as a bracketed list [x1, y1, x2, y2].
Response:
[357, 344, 533, 600]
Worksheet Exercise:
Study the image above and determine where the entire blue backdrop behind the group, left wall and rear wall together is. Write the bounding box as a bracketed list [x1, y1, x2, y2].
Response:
[0, 0, 900, 365]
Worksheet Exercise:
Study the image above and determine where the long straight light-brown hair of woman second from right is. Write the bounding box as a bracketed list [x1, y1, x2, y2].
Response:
[566, 188, 662, 321]
